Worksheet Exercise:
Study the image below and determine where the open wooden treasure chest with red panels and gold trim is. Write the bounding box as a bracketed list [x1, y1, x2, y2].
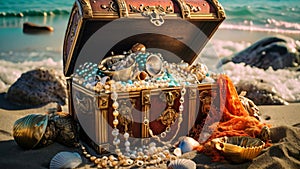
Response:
[63, 0, 225, 153]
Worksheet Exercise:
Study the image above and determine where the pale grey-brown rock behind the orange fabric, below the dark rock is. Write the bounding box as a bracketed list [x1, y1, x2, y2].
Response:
[235, 80, 288, 105]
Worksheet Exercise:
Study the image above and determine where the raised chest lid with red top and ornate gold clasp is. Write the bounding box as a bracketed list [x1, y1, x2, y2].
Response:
[63, 0, 225, 76]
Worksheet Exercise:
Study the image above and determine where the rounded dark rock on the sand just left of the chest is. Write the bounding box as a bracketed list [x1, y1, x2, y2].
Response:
[5, 68, 67, 106]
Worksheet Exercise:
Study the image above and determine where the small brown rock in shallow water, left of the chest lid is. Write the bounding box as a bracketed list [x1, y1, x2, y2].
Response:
[23, 22, 54, 34]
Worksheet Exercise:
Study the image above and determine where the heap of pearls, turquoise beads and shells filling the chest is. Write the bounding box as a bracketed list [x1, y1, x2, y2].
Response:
[73, 44, 209, 93]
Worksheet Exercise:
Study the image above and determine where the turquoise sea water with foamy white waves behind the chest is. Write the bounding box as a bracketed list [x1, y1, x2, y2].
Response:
[0, 0, 300, 101]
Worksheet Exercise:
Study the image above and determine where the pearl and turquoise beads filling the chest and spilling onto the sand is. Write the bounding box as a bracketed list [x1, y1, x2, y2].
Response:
[72, 46, 211, 168]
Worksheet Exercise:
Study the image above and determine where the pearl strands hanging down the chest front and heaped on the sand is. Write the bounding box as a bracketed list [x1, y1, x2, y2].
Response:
[81, 84, 186, 168]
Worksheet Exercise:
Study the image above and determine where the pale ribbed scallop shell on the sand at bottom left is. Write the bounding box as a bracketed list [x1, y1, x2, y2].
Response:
[49, 151, 82, 169]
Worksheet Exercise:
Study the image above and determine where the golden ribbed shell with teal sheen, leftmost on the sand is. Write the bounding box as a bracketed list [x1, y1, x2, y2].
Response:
[13, 114, 48, 149]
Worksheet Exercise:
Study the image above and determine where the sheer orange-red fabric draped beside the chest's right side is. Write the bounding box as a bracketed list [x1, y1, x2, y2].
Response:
[196, 75, 266, 161]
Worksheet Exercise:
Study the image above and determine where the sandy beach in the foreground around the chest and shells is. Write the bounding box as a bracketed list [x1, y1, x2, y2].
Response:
[0, 95, 300, 169]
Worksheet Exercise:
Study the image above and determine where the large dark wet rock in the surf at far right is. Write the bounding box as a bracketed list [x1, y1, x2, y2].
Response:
[218, 36, 300, 70]
